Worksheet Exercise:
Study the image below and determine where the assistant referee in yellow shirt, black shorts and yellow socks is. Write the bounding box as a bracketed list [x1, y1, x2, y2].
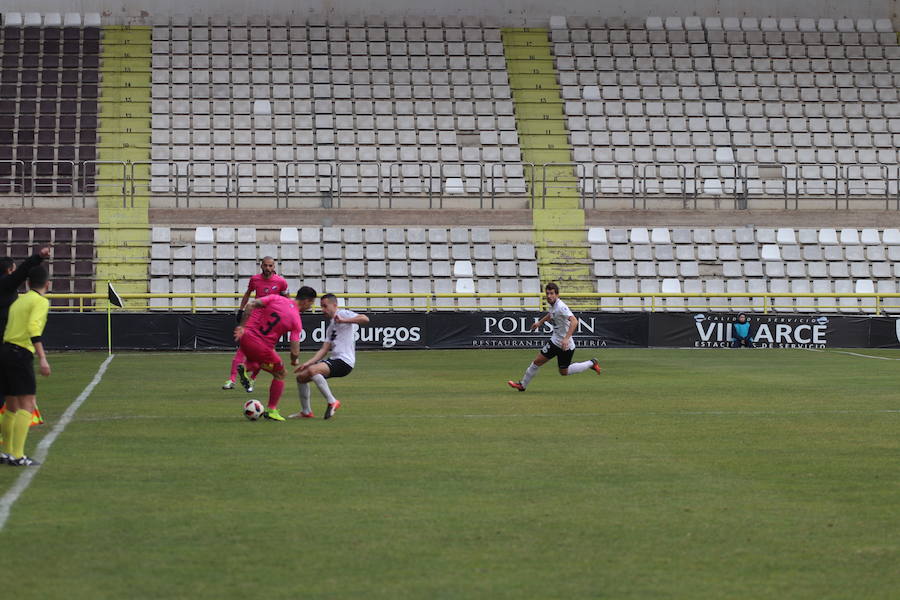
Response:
[0, 267, 50, 467]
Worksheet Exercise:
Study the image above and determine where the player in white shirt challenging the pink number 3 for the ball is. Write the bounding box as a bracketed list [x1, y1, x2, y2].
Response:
[290, 294, 369, 419]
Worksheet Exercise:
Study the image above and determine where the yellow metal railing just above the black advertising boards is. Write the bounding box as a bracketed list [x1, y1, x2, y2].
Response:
[47, 292, 900, 315]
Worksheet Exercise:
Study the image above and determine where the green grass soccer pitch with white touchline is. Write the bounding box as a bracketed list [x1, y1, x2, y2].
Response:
[0, 350, 900, 599]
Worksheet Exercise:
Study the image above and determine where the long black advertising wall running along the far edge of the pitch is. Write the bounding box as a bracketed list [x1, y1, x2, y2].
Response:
[43, 311, 900, 352]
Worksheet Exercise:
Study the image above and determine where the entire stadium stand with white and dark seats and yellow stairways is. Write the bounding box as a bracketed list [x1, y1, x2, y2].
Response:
[0, 13, 900, 312]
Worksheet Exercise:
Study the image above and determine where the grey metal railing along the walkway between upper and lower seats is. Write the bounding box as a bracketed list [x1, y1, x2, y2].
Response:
[7, 160, 900, 210]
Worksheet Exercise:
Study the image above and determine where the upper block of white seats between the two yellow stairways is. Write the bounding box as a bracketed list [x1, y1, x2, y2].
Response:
[152, 18, 525, 194]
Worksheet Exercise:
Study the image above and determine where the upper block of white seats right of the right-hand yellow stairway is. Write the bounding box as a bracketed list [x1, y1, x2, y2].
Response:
[552, 17, 900, 196]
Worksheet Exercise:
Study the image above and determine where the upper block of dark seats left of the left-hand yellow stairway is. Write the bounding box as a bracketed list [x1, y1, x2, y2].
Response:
[0, 14, 100, 194]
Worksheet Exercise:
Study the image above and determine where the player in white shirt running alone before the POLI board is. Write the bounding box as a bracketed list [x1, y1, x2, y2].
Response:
[506, 283, 600, 392]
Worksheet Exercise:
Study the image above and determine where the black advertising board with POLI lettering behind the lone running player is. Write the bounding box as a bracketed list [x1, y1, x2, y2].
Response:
[427, 312, 648, 349]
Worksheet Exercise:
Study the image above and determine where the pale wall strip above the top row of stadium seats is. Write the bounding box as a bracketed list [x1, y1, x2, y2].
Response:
[0, 0, 900, 26]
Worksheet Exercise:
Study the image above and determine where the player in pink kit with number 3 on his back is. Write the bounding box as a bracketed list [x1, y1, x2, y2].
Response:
[234, 286, 316, 421]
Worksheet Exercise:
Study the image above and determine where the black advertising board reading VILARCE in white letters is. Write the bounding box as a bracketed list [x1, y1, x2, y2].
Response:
[649, 313, 871, 348]
